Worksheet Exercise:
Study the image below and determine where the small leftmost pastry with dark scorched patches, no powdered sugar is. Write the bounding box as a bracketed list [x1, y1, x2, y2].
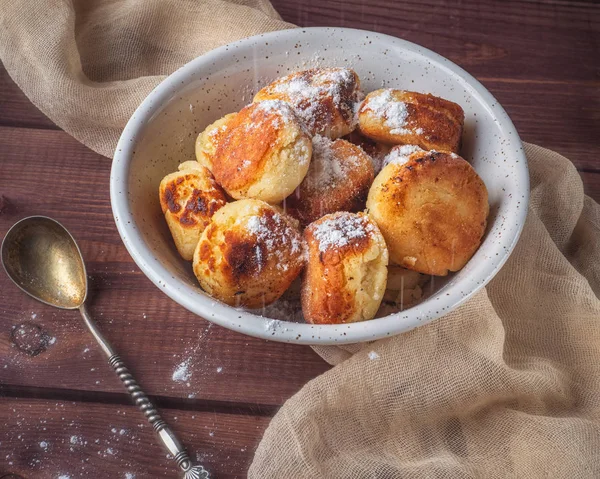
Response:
[159, 161, 227, 261]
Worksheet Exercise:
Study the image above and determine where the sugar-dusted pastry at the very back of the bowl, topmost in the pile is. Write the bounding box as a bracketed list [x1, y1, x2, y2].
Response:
[254, 68, 360, 139]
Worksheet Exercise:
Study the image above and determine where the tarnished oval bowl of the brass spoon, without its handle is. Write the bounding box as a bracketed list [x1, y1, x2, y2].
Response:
[2, 216, 87, 309]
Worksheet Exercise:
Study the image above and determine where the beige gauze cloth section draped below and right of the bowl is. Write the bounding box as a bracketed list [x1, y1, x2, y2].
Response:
[250, 144, 600, 479]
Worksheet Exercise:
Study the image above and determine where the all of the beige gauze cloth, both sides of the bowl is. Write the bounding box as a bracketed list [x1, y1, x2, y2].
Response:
[0, 0, 600, 479]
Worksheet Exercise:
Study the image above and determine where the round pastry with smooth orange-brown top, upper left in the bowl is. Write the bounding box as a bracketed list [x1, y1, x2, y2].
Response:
[213, 100, 312, 203]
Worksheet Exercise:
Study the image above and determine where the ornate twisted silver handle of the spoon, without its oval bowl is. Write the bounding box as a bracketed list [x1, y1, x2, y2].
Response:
[79, 305, 210, 479]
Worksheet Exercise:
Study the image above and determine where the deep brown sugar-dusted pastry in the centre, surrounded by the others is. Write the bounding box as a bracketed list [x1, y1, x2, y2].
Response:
[286, 136, 375, 226]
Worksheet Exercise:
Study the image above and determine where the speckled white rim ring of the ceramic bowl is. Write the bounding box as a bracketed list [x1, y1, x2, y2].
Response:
[110, 27, 529, 345]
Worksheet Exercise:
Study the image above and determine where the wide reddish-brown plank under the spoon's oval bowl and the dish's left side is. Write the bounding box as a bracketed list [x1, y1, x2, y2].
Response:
[0, 128, 329, 406]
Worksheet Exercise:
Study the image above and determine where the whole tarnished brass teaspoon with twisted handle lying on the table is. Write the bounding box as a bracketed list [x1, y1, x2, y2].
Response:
[1, 216, 209, 479]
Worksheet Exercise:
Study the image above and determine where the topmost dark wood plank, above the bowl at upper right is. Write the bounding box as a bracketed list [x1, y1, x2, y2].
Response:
[273, 0, 600, 81]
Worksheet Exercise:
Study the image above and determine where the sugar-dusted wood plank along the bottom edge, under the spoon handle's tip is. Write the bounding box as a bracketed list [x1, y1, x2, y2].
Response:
[0, 397, 270, 479]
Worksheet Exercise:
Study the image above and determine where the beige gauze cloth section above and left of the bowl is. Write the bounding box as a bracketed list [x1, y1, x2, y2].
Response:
[0, 0, 293, 157]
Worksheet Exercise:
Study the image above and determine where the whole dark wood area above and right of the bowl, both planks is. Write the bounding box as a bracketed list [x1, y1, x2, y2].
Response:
[273, 0, 600, 170]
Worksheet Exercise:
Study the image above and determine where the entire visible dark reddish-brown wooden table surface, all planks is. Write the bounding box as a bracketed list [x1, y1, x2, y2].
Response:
[0, 0, 600, 479]
